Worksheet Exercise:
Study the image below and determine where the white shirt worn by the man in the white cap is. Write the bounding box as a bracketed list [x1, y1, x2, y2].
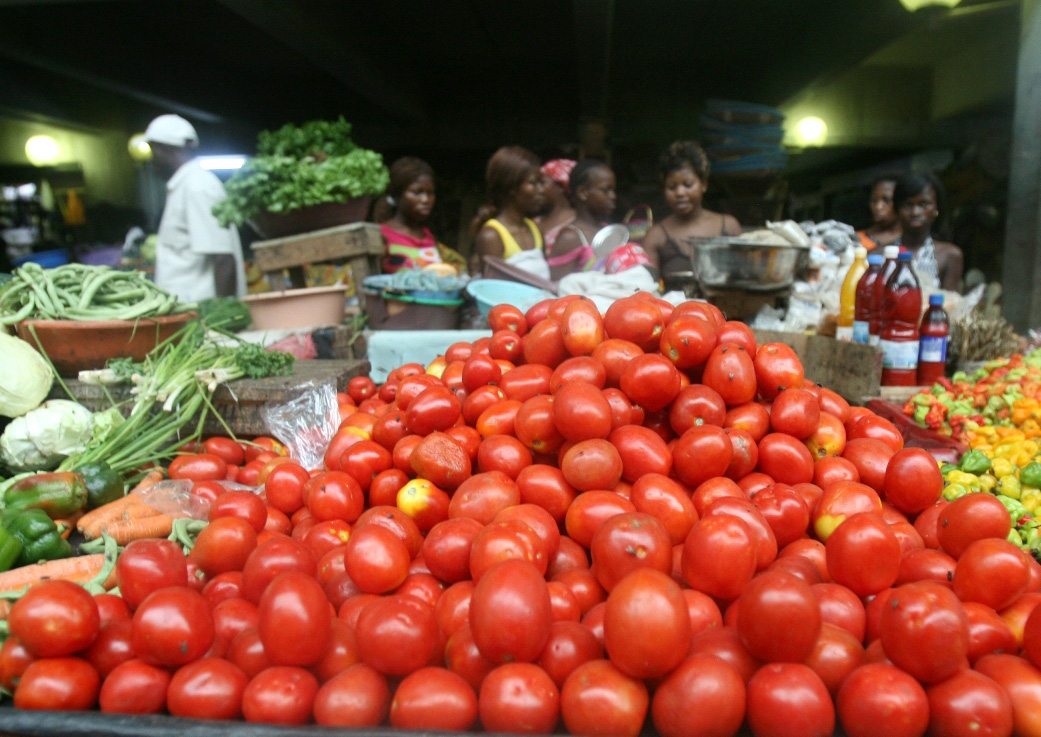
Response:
[155, 159, 246, 302]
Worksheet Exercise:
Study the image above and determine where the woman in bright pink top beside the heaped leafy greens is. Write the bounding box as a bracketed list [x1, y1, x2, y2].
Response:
[373, 156, 466, 274]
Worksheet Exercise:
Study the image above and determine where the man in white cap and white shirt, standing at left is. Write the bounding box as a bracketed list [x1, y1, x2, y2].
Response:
[145, 115, 246, 302]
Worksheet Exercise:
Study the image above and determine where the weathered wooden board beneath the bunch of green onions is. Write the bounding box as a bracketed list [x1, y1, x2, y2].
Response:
[50, 359, 369, 436]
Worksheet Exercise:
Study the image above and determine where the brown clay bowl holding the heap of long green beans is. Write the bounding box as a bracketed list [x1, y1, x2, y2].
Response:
[17, 312, 197, 377]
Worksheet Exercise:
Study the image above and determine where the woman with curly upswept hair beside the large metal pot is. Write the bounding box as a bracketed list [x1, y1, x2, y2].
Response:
[643, 141, 741, 288]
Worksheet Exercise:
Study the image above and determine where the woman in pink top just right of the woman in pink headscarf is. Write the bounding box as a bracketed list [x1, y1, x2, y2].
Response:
[545, 158, 615, 281]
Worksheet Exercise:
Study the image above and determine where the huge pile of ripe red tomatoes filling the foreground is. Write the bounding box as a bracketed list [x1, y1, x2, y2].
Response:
[0, 295, 1041, 737]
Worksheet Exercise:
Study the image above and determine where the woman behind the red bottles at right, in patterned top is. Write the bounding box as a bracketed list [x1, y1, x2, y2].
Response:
[893, 173, 964, 291]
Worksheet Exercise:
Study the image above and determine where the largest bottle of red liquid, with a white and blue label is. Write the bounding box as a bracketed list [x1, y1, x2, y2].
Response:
[879, 251, 921, 386]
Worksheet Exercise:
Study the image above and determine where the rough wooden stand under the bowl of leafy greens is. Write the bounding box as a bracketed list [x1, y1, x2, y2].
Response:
[253, 223, 386, 307]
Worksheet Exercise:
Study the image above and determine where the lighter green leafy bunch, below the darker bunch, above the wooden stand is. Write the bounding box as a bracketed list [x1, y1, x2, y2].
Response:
[213, 148, 389, 226]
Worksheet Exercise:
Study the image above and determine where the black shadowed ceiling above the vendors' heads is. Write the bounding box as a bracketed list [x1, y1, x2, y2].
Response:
[0, 0, 953, 149]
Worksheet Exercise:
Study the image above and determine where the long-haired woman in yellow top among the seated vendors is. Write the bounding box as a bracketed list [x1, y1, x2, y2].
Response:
[469, 146, 543, 274]
